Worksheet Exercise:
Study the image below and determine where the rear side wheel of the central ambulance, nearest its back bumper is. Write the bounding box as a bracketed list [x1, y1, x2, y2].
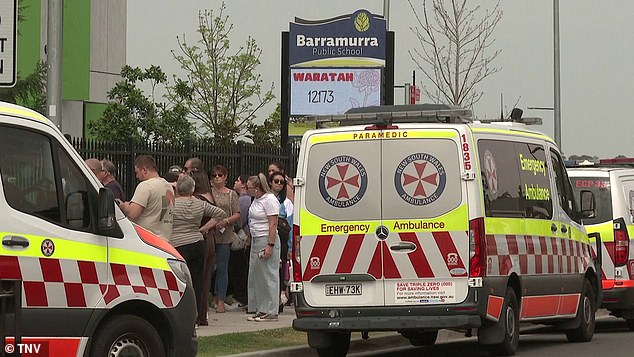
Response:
[489, 288, 520, 356]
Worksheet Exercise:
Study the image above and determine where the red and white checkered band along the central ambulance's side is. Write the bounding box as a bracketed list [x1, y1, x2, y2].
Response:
[486, 234, 592, 276]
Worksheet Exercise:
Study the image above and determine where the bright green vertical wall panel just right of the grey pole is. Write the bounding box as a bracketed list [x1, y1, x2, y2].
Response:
[62, 0, 90, 100]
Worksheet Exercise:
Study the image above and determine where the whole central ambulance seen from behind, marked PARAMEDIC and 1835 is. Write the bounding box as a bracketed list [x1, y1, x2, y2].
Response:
[291, 105, 601, 356]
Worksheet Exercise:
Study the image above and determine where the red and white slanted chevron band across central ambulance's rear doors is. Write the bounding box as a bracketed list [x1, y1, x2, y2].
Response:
[301, 231, 469, 281]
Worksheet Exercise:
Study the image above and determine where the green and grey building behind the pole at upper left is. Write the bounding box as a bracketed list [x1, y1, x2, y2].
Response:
[17, 0, 127, 137]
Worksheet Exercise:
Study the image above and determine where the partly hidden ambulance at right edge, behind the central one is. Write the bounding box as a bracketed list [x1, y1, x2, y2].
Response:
[568, 158, 634, 331]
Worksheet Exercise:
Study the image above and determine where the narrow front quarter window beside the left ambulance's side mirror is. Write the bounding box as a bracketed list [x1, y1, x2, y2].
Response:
[58, 148, 96, 231]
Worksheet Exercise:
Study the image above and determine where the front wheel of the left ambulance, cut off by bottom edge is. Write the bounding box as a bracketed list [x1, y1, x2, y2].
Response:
[90, 315, 165, 357]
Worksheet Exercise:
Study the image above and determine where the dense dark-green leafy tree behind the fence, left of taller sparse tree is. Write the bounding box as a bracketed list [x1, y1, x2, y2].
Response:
[88, 65, 194, 143]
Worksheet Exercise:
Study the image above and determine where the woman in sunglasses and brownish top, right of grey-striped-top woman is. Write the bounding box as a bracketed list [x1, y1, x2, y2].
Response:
[209, 165, 240, 313]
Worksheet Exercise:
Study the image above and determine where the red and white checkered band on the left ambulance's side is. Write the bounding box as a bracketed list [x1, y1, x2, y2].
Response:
[0, 256, 185, 308]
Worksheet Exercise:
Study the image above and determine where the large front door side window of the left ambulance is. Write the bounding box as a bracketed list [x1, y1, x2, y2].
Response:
[0, 127, 60, 222]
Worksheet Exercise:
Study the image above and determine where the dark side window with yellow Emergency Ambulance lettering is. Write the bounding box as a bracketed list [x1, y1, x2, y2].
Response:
[515, 142, 553, 219]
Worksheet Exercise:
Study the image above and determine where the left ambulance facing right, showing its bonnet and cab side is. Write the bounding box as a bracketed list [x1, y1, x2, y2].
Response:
[0, 103, 197, 357]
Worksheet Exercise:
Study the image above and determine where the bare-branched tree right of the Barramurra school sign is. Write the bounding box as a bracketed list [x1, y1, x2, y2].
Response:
[409, 0, 502, 107]
